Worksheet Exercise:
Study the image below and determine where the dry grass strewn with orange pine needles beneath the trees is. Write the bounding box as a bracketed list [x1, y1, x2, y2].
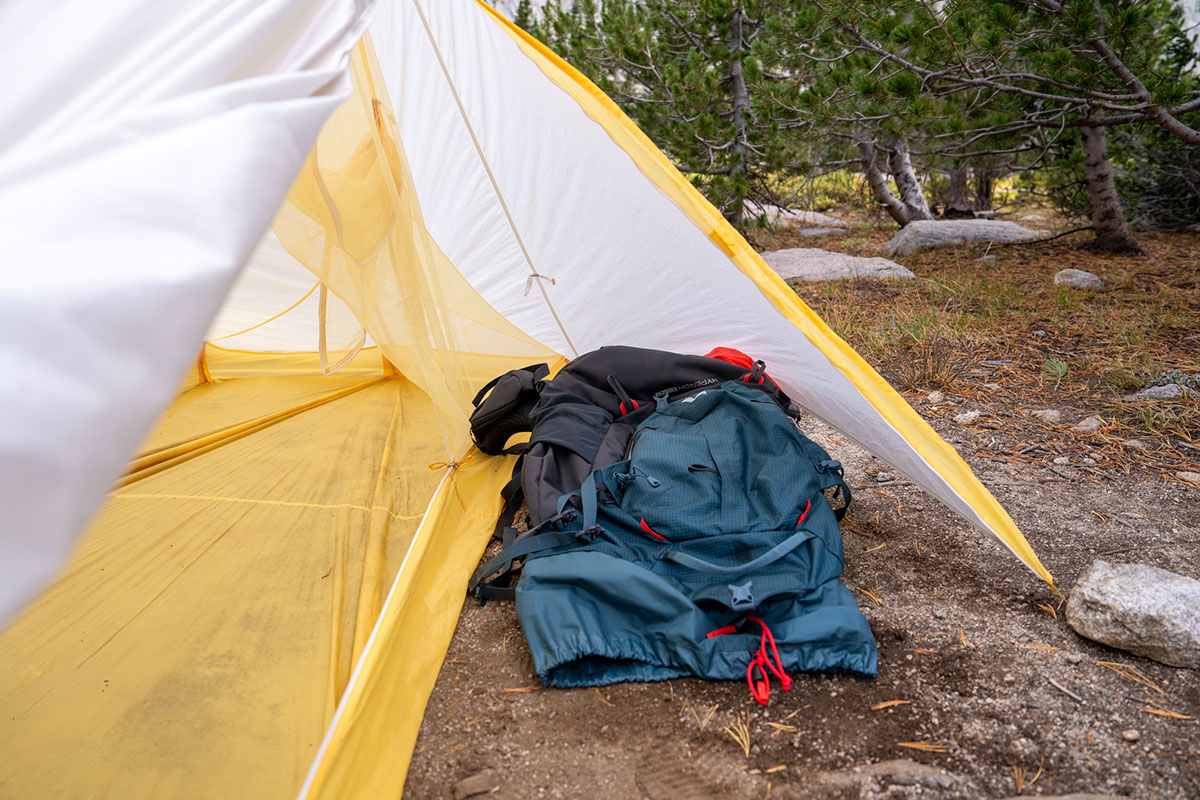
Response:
[768, 221, 1200, 480]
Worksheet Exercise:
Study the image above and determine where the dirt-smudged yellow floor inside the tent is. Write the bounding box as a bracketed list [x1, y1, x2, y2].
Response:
[0, 364, 453, 798]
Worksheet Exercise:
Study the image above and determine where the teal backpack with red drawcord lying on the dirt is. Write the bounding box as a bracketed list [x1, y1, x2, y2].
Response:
[469, 348, 877, 704]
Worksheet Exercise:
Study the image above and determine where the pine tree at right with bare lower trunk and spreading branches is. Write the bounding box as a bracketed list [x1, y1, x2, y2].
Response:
[784, 0, 1200, 251]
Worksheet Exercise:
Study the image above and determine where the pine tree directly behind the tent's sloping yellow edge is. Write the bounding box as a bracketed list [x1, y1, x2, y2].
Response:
[535, 0, 796, 229]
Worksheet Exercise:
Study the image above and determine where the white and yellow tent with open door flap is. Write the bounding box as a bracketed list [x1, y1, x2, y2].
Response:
[0, 0, 1050, 798]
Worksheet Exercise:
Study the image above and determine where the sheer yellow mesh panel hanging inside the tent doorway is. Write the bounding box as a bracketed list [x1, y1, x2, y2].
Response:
[272, 40, 558, 440]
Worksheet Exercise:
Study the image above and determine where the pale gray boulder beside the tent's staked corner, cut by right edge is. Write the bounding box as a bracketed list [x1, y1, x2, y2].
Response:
[1067, 560, 1200, 668]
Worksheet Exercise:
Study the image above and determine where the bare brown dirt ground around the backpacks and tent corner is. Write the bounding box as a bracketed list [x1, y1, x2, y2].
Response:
[404, 230, 1200, 800]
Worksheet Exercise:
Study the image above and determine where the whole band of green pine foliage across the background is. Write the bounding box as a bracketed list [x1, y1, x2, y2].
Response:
[537, 0, 1200, 229]
